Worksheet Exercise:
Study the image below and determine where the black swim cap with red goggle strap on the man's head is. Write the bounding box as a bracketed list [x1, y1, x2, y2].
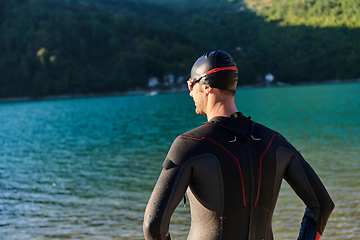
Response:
[191, 50, 238, 91]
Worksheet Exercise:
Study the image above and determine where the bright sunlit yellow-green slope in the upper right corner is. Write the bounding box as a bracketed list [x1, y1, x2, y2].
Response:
[245, 0, 360, 28]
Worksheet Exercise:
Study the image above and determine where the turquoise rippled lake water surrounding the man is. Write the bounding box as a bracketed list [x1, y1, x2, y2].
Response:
[0, 83, 360, 240]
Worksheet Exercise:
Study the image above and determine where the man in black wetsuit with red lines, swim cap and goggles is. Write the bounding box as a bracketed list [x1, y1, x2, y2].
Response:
[143, 50, 334, 240]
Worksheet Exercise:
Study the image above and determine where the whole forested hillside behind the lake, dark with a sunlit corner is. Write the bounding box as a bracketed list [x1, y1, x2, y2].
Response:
[0, 0, 360, 98]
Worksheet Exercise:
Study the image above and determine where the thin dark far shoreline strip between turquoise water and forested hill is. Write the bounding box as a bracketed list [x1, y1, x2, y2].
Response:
[0, 78, 360, 104]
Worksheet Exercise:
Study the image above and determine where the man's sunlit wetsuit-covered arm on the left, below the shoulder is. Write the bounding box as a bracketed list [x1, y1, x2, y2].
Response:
[143, 159, 191, 240]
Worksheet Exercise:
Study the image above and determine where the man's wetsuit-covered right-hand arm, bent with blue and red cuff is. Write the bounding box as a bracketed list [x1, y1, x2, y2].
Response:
[285, 150, 334, 240]
